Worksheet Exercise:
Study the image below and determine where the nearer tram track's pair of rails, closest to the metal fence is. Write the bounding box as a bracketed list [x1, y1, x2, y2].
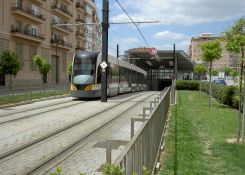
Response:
[0, 91, 154, 174]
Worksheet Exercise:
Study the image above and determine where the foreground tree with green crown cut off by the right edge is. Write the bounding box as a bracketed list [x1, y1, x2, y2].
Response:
[223, 18, 245, 143]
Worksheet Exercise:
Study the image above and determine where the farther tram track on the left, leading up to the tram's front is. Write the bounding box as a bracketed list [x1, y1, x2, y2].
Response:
[0, 98, 85, 125]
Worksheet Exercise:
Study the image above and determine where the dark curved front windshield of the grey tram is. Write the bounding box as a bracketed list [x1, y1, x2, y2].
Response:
[73, 59, 95, 84]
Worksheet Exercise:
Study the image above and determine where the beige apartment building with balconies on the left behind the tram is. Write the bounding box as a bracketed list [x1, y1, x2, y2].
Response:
[0, 0, 101, 87]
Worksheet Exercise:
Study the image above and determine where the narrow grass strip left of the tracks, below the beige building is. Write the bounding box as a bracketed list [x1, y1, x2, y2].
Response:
[0, 88, 70, 106]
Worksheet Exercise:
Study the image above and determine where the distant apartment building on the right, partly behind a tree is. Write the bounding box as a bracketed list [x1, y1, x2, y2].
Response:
[188, 33, 237, 69]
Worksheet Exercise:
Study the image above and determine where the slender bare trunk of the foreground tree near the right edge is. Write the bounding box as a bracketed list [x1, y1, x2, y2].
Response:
[237, 60, 243, 143]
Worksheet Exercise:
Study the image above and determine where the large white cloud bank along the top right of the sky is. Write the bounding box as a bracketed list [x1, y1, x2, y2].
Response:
[111, 0, 245, 25]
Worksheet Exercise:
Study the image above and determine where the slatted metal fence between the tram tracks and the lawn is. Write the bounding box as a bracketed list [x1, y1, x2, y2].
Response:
[114, 87, 171, 175]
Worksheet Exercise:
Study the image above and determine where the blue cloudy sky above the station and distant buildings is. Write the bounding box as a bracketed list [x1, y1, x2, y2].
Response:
[95, 0, 245, 55]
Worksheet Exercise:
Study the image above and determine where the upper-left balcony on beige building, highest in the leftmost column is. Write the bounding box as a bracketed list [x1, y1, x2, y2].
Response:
[12, 4, 46, 23]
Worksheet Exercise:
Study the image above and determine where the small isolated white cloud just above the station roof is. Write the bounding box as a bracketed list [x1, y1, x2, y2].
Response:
[153, 31, 188, 40]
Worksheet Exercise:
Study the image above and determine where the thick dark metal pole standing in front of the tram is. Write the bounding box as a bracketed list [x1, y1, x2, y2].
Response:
[101, 0, 109, 102]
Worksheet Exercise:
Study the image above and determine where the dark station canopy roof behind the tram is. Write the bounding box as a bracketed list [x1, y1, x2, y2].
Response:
[127, 48, 195, 72]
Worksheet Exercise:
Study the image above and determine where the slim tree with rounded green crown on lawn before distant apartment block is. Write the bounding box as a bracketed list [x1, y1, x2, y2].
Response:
[199, 40, 222, 109]
